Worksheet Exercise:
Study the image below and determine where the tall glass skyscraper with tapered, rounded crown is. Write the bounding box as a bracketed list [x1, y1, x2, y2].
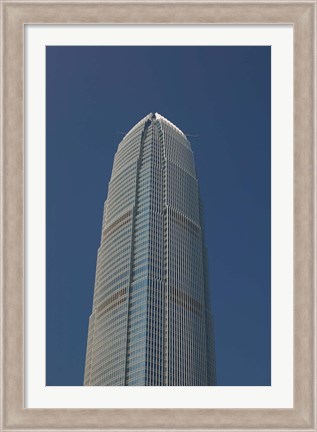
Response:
[84, 113, 216, 386]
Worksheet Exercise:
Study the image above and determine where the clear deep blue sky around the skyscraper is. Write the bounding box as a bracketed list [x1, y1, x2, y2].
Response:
[46, 47, 271, 386]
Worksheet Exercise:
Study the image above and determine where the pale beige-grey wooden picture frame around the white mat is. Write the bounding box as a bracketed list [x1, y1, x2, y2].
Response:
[1, 0, 316, 431]
